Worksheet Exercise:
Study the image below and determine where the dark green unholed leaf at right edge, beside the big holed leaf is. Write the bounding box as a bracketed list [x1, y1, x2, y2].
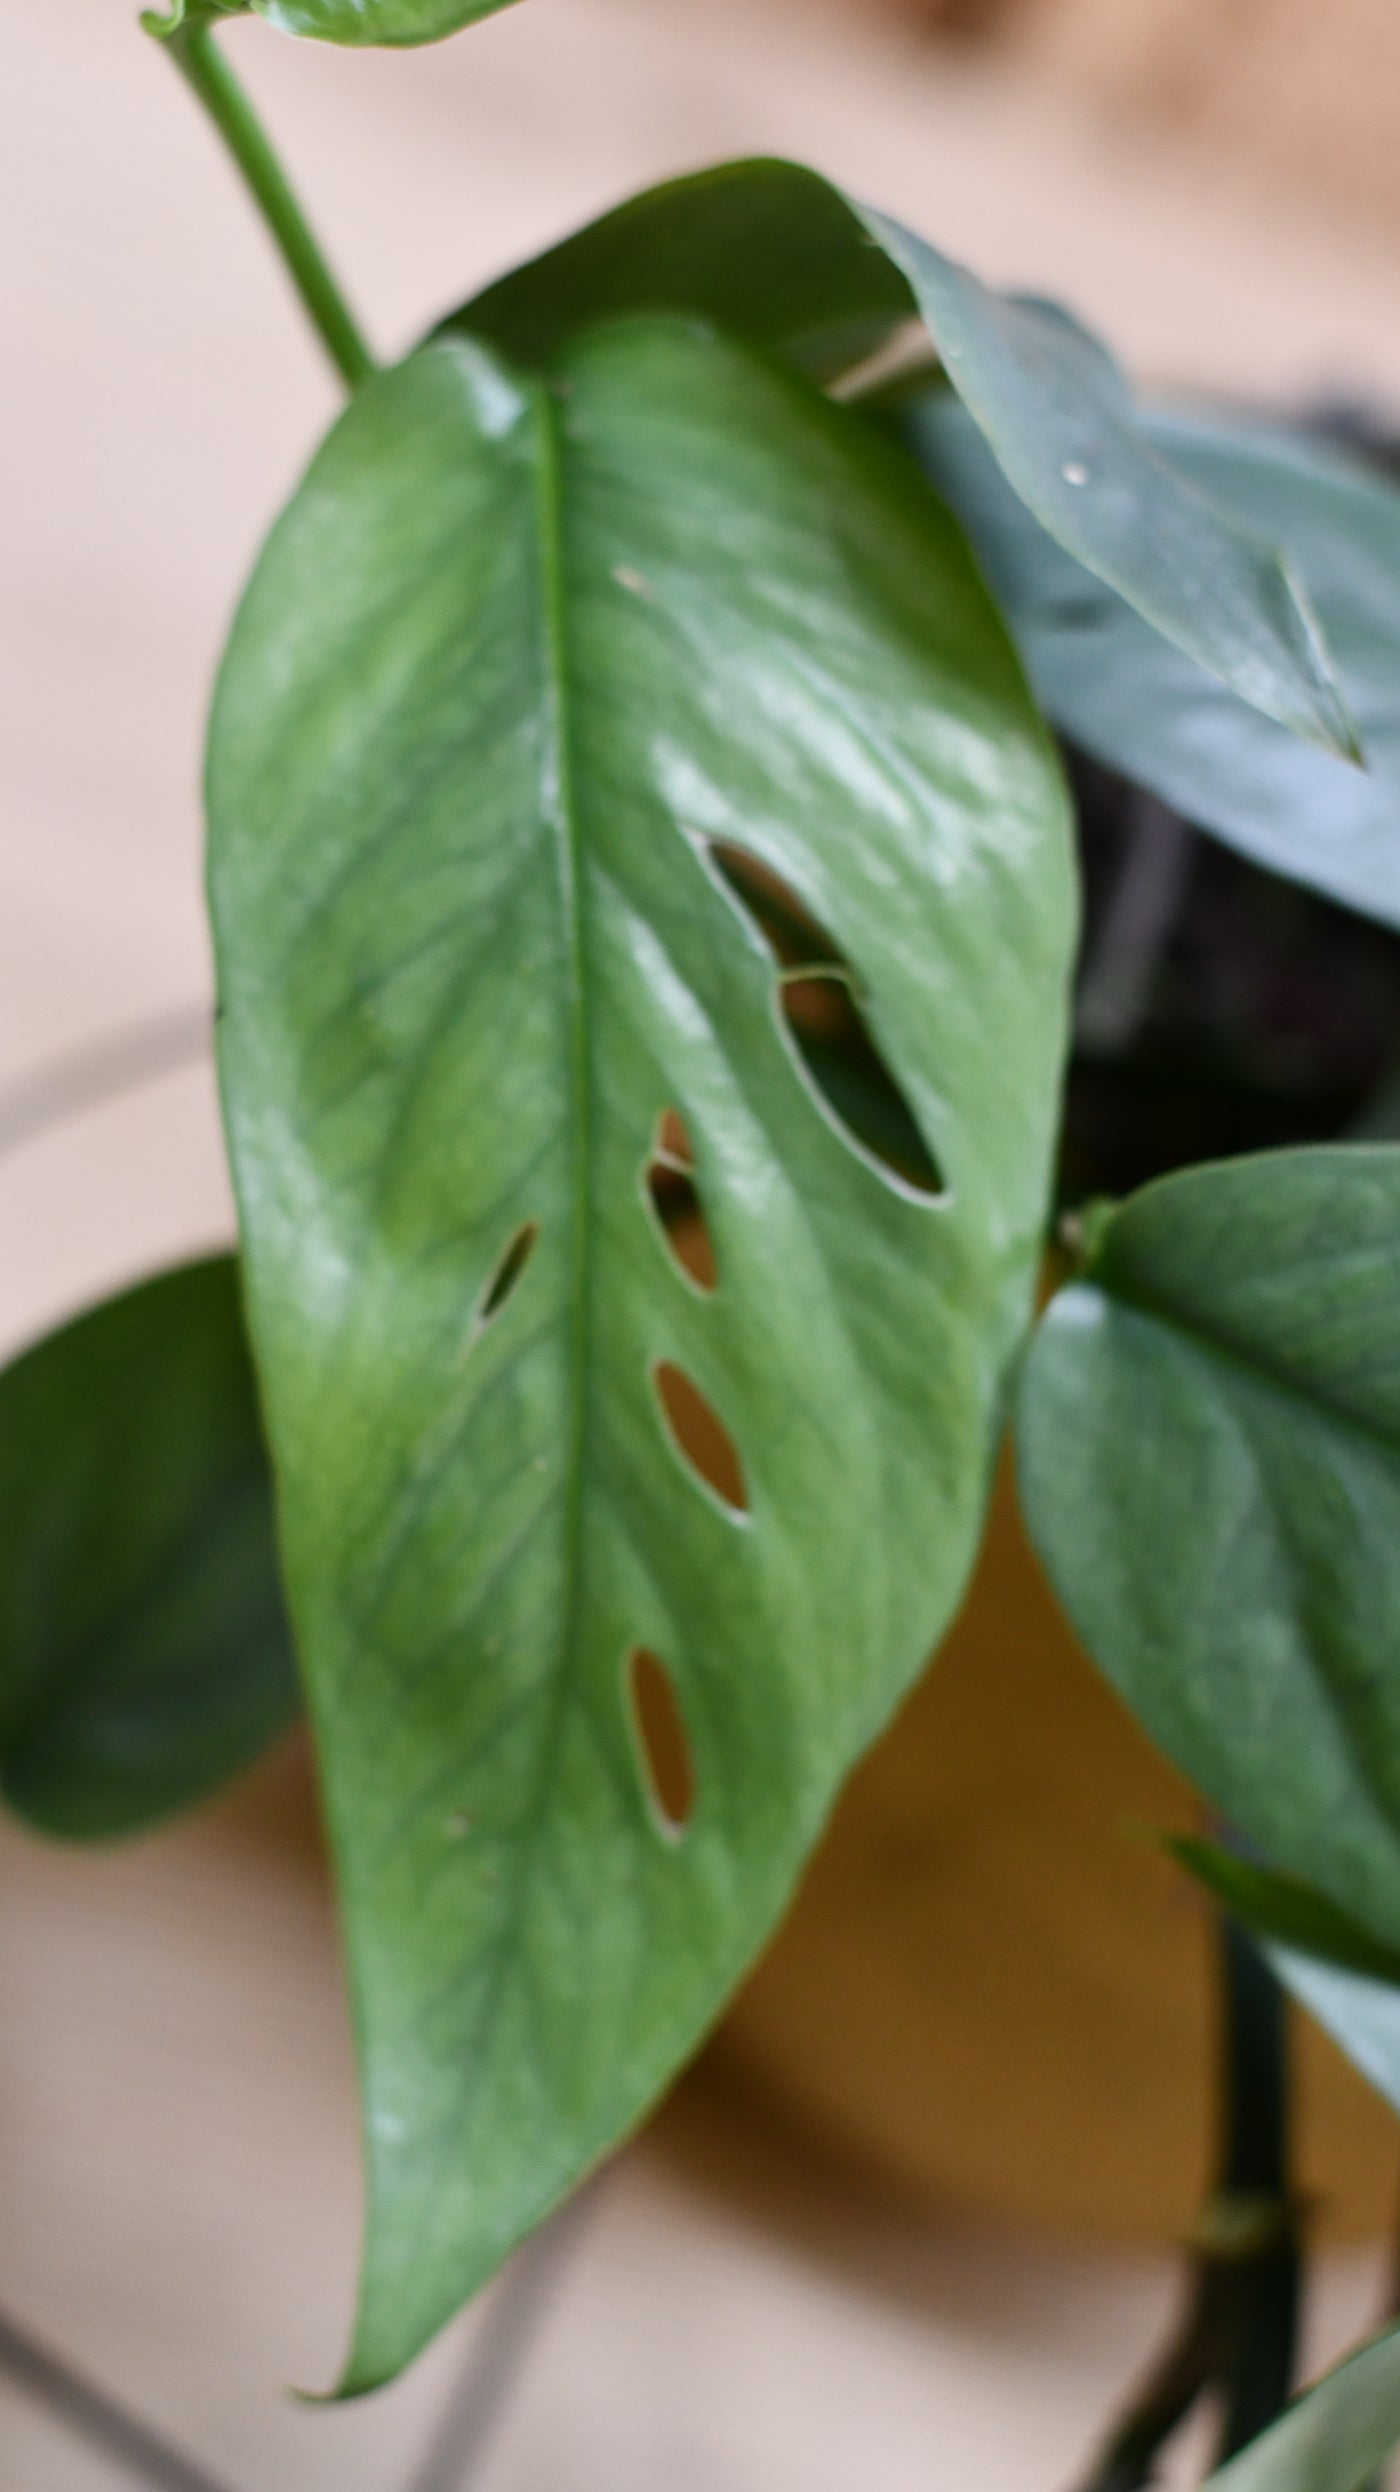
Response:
[1019, 1146, 1400, 1949]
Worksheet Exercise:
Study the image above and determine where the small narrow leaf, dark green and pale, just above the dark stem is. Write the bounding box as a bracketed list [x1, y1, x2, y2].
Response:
[1171, 1839, 1400, 2111]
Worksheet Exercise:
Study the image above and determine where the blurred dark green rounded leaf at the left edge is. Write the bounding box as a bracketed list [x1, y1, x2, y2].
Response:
[0, 1258, 296, 1837]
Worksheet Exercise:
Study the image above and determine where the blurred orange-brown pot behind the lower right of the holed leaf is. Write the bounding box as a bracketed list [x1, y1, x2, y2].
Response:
[715, 1480, 1400, 2243]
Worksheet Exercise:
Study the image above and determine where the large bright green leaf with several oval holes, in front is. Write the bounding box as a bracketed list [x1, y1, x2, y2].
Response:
[209, 321, 1071, 2387]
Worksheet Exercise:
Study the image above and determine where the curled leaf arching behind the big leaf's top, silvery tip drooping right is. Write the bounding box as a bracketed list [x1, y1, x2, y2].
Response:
[456, 159, 1355, 758]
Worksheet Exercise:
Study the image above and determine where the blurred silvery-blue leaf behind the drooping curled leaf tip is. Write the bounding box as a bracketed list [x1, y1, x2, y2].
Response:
[899, 389, 1400, 925]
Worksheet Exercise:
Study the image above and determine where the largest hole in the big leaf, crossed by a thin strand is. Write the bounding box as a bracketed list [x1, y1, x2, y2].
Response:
[712, 842, 944, 1194]
